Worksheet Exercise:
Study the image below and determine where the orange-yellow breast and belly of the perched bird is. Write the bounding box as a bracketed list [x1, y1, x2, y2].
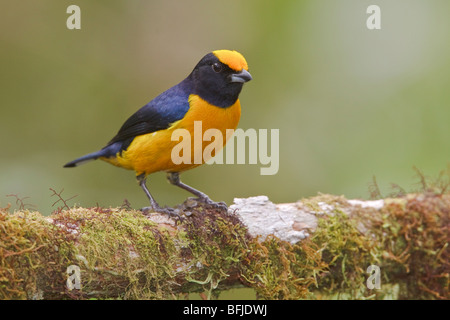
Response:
[102, 95, 241, 175]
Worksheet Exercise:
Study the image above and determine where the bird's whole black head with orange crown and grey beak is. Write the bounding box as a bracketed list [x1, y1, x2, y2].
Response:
[190, 50, 252, 108]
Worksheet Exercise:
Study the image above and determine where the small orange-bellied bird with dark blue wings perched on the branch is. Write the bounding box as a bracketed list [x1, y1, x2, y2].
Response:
[64, 50, 252, 216]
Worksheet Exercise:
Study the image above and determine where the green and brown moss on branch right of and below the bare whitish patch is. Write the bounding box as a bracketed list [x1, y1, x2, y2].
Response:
[239, 193, 450, 299]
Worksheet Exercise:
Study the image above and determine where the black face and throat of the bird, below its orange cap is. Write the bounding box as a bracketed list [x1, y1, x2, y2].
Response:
[190, 53, 248, 108]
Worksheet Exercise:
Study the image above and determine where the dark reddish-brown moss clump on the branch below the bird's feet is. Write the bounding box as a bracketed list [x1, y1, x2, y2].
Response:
[178, 204, 251, 297]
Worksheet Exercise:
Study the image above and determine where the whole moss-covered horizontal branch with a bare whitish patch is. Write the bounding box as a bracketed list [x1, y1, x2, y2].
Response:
[0, 193, 450, 299]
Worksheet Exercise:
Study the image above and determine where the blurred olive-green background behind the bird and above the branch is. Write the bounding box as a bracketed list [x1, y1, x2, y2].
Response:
[0, 0, 450, 214]
